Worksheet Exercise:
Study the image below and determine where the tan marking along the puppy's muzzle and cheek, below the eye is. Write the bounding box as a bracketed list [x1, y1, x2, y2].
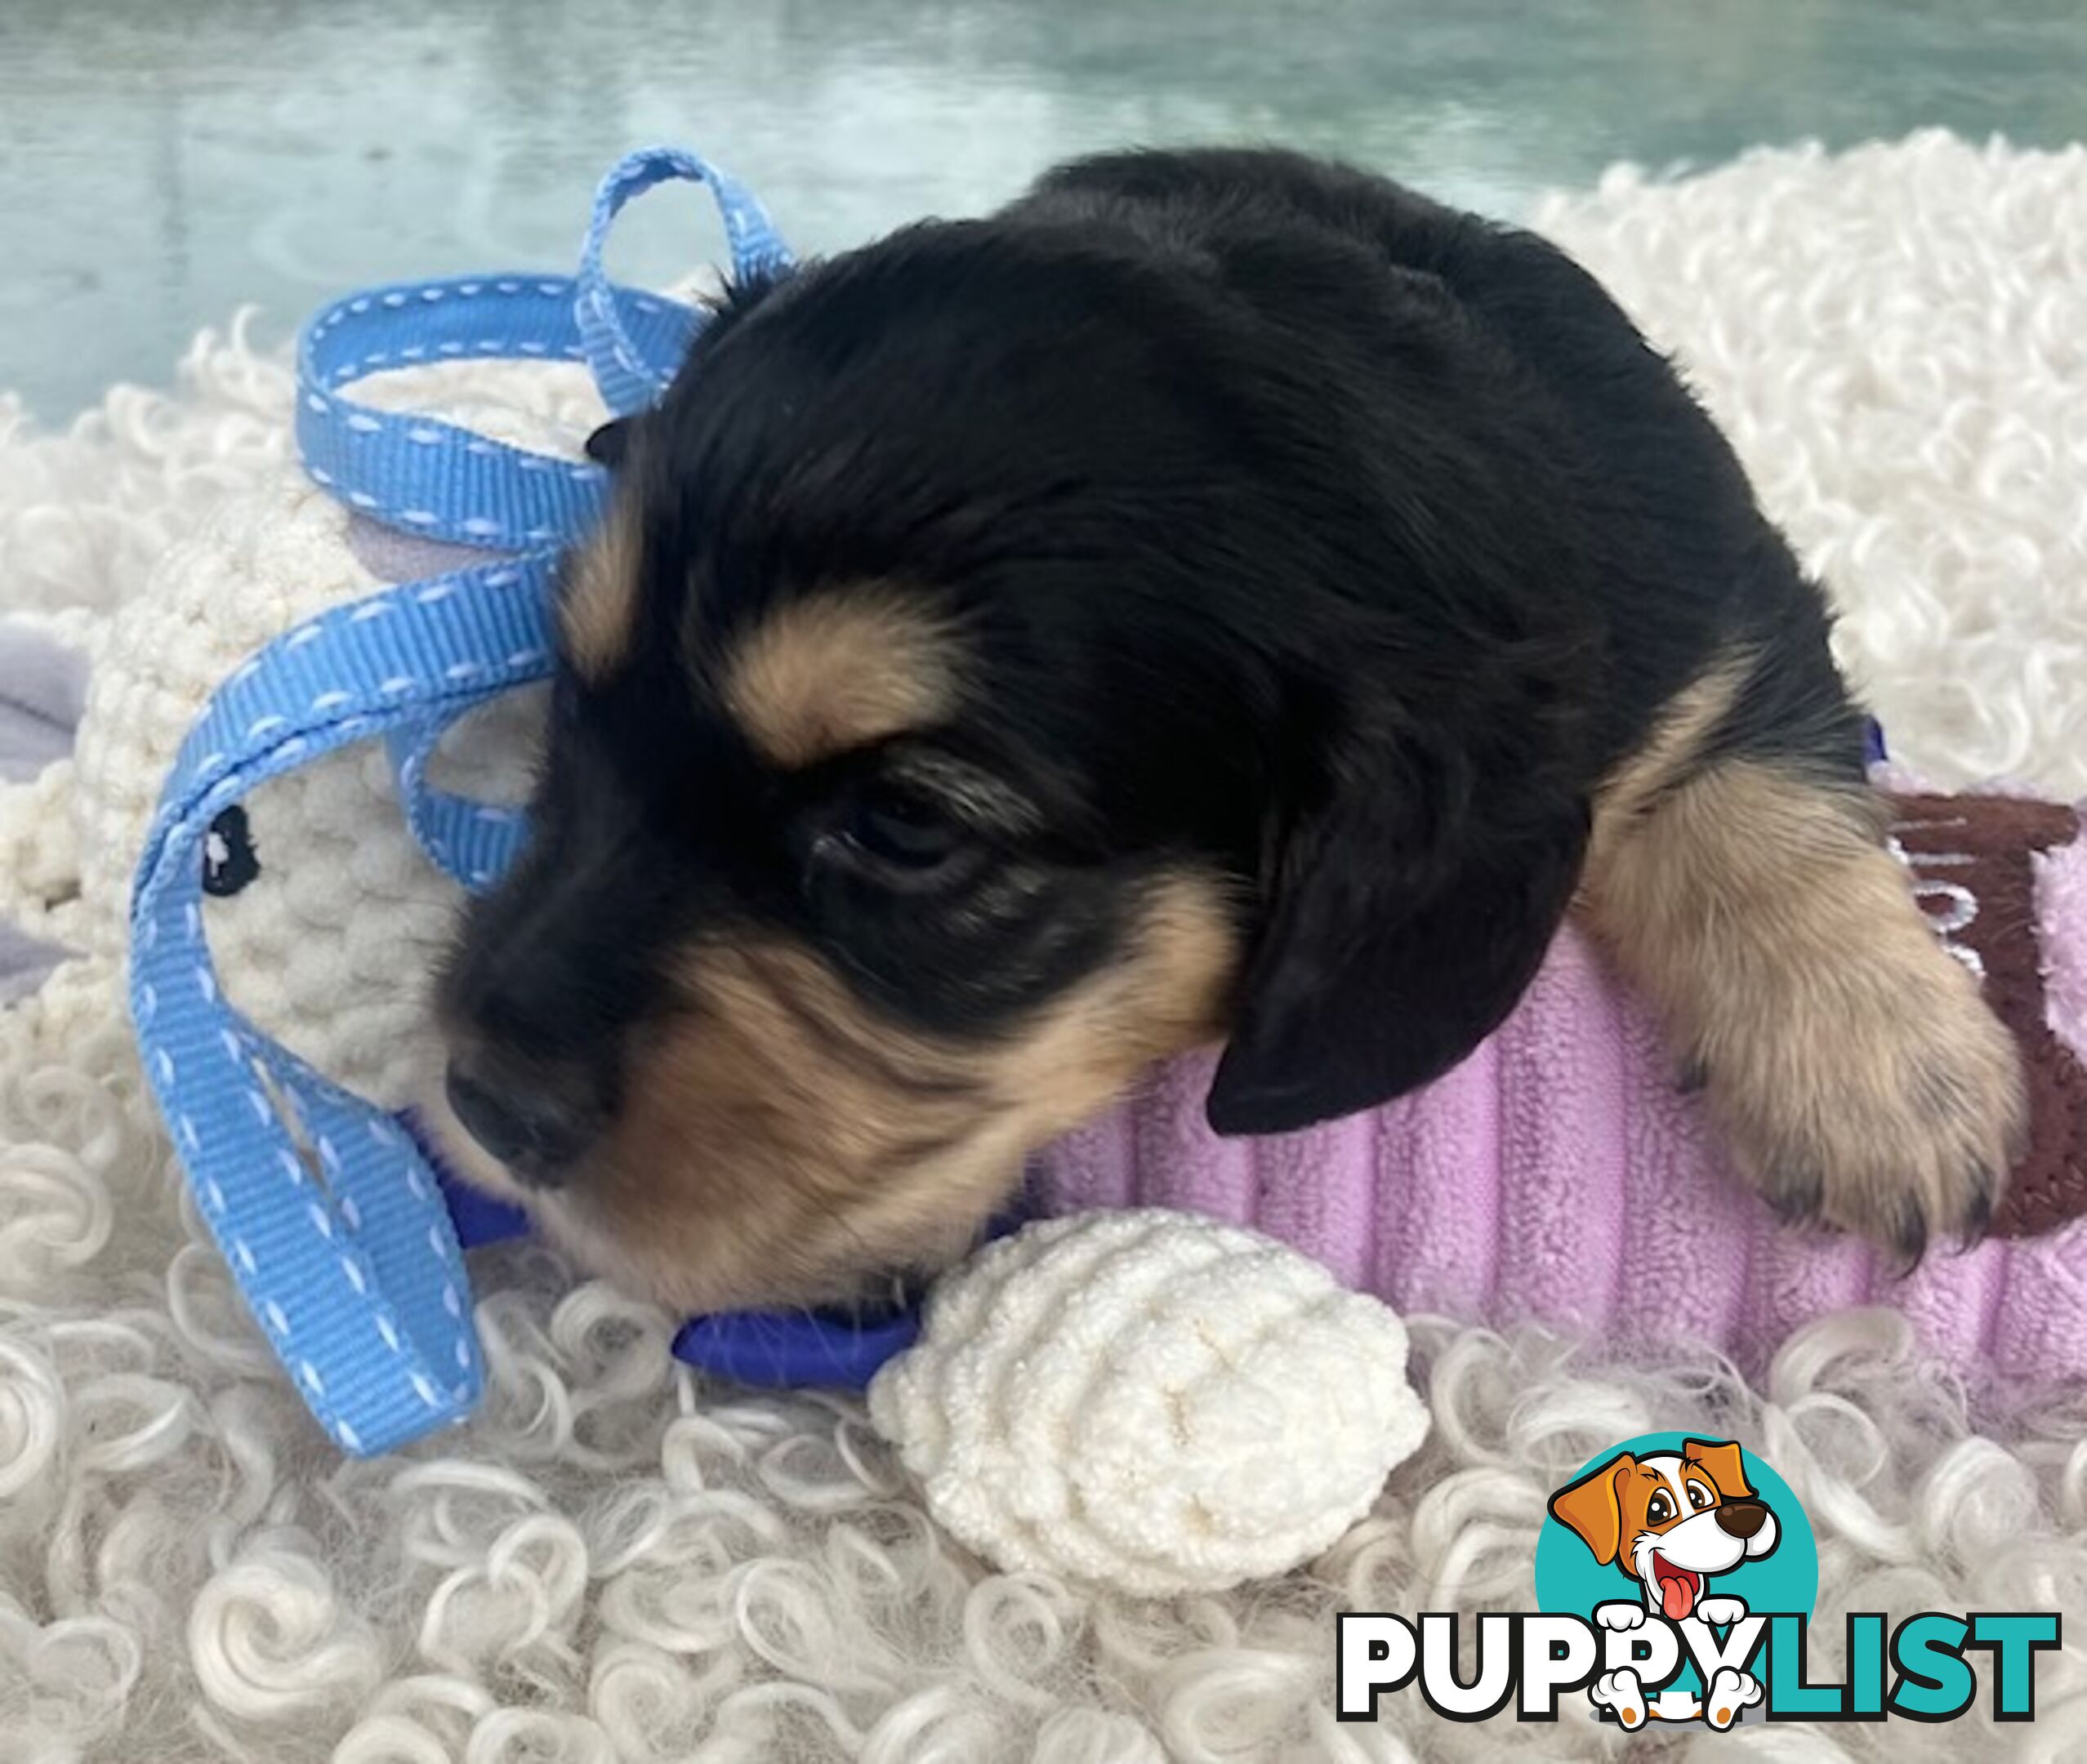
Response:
[553, 877, 1237, 1309]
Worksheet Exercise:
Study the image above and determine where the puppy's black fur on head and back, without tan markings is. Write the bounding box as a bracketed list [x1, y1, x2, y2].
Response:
[447, 150, 1862, 1131]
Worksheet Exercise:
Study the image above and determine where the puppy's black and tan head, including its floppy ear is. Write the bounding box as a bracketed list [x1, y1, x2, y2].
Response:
[439, 212, 1586, 1309]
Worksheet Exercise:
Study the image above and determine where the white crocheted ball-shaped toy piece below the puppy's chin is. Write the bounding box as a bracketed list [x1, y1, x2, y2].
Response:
[870, 1209, 1428, 1595]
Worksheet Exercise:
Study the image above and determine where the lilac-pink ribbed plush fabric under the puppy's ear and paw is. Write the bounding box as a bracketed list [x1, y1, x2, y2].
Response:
[1039, 797, 2087, 1386]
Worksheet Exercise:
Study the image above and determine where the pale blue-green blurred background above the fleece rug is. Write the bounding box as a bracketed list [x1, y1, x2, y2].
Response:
[0, 0, 2087, 420]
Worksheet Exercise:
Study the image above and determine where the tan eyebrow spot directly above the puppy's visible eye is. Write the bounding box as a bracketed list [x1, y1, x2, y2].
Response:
[725, 585, 956, 768]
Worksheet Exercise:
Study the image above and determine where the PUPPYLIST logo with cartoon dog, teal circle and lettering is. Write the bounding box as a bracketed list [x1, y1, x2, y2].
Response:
[1336, 1434, 2060, 1733]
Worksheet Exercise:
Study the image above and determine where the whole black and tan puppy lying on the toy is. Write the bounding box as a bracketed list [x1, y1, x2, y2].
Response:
[427, 153, 2022, 1309]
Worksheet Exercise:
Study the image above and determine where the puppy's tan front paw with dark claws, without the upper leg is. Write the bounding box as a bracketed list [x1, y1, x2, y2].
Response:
[1705, 931, 2028, 1263]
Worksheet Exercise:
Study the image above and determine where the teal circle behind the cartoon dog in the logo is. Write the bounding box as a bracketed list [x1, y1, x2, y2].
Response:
[1536, 1434, 1820, 1628]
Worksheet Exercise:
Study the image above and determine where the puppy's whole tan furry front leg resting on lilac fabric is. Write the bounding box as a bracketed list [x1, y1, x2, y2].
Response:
[1586, 758, 2027, 1261]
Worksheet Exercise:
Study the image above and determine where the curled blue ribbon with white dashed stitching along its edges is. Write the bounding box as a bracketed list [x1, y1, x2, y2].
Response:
[129, 148, 791, 1455]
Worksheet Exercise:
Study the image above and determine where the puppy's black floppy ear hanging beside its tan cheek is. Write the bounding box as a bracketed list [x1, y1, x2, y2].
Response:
[1204, 701, 1590, 1134]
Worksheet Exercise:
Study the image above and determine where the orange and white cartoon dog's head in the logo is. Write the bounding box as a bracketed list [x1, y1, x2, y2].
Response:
[1550, 1438, 1780, 1622]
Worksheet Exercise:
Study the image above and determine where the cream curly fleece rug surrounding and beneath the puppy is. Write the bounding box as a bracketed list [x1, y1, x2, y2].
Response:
[0, 136, 2087, 1764]
